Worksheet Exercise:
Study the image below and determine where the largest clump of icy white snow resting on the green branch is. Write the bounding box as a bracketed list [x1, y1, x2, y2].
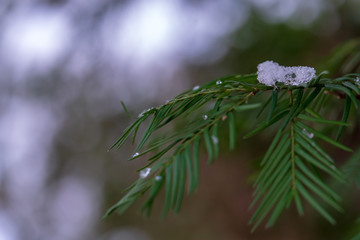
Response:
[257, 61, 316, 86]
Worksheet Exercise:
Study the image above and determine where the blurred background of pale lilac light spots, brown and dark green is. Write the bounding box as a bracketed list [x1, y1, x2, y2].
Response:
[0, 0, 360, 240]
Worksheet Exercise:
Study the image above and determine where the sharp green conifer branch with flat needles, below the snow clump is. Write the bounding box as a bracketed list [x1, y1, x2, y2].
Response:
[105, 40, 360, 230]
